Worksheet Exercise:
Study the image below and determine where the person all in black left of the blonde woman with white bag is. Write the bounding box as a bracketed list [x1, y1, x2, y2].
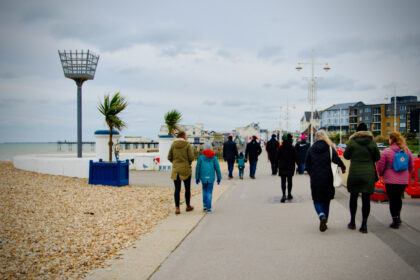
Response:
[276, 134, 298, 203]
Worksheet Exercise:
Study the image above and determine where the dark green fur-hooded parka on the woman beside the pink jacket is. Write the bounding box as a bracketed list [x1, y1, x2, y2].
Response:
[344, 131, 381, 194]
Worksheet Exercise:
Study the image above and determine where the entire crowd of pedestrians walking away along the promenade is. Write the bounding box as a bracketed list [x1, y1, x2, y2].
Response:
[168, 126, 413, 233]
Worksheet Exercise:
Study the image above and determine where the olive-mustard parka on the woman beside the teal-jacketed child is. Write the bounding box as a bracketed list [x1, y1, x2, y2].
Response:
[168, 138, 194, 180]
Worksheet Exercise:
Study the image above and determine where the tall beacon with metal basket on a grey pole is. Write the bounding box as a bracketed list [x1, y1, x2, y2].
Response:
[58, 50, 99, 158]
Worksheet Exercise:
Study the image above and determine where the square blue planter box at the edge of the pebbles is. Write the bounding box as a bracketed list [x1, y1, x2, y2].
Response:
[89, 159, 130, 187]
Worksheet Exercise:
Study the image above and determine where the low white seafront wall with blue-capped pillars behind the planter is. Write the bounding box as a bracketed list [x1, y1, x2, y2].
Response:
[13, 130, 174, 178]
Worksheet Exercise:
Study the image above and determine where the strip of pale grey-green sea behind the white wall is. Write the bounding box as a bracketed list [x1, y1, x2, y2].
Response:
[0, 142, 95, 161]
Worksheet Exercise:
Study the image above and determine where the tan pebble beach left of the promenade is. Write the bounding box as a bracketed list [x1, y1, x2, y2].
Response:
[0, 162, 201, 279]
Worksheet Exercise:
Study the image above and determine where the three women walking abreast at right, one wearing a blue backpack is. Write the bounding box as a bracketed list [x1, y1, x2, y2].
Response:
[305, 123, 413, 233]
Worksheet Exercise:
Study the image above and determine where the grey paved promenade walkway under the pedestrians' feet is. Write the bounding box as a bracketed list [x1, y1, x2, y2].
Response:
[151, 160, 420, 280]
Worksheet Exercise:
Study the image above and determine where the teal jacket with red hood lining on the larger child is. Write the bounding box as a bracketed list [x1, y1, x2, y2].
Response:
[195, 150, 222, 183]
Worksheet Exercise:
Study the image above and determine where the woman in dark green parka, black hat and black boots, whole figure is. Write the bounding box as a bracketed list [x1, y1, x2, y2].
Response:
[344, 123, 380, 233]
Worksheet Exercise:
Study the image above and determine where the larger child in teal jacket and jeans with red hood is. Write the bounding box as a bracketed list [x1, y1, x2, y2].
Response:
[195, 142, 222, 213]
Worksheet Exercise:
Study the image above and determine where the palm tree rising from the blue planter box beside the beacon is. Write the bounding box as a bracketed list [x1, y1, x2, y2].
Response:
[98, 92, 128, 162]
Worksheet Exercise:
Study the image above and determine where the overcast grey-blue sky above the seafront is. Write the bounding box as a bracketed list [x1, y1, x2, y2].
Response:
[0, 0, 420, 142]
